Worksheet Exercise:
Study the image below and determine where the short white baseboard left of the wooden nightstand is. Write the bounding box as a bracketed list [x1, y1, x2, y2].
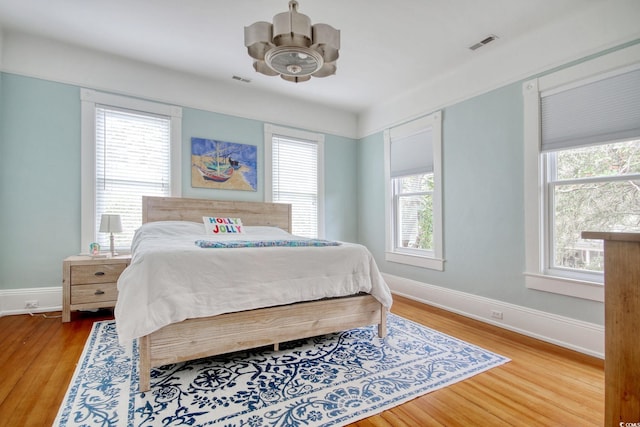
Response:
[0, 286, 62, 316]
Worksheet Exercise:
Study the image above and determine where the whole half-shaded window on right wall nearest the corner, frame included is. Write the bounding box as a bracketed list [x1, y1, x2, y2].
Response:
[385, 112, 443, 271]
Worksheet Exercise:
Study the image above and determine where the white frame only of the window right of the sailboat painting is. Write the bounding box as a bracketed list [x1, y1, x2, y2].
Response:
[264, 123, 325, 239]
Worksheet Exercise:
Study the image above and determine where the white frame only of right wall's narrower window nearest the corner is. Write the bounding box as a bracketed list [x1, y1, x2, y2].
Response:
[384, 111, 445, 271]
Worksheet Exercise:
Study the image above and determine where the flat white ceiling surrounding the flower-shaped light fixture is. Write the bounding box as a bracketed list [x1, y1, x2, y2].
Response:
[0, 0, 640, 113]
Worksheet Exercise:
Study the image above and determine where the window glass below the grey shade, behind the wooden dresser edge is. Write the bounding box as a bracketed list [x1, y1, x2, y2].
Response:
[542, 139, 640, 281]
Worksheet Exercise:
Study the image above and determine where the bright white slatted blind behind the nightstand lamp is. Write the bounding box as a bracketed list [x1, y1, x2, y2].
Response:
[95, 106, 171, 249]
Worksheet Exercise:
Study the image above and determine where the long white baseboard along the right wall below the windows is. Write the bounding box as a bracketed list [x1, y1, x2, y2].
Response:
[383, 274, 604, 359]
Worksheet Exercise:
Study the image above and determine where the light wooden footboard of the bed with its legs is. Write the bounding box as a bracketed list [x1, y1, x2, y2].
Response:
[139, 295, 387, 392]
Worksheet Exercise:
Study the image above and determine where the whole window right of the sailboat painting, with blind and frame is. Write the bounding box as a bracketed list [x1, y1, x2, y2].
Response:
[265, 124, 324, 238]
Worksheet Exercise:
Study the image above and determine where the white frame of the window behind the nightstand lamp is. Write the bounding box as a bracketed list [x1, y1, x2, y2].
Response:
[80, 89, 182, 253]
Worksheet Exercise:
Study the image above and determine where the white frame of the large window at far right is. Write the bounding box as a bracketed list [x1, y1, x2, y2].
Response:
[522, 45, 640, 302]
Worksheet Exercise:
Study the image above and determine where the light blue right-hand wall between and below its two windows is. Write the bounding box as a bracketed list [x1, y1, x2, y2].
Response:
[358, 83, 603, 324]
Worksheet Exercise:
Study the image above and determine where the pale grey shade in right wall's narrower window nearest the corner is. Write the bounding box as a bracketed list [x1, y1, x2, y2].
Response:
[389, 119, 433, 178]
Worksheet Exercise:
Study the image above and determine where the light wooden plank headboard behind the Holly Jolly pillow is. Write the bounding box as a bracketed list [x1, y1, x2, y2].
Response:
[142, 196, 291, 232]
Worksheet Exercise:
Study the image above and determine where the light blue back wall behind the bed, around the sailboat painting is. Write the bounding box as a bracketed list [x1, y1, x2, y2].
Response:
[0, 73, 357, 289]
